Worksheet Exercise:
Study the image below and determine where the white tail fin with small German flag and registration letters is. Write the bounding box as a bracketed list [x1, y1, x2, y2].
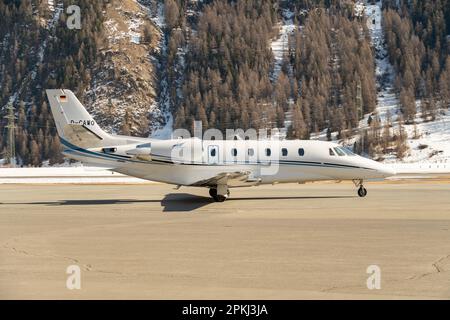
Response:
[46, 89, 109, 148]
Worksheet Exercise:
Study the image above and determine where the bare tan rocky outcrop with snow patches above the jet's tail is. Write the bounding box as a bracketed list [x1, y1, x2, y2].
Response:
[86, 0, 161, 135]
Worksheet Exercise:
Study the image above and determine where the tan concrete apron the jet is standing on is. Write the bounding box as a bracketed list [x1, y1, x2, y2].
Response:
[0, 181, 450, 299]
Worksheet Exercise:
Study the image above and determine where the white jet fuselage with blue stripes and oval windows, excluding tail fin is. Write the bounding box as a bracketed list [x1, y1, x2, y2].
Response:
[59, 137, 395, 187]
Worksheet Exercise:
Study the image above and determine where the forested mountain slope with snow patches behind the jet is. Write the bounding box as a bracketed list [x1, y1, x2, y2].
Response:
[0, 0, 450, 165]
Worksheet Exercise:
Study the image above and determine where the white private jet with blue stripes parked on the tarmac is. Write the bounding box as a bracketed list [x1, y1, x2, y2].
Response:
[46, 89, 395, 202]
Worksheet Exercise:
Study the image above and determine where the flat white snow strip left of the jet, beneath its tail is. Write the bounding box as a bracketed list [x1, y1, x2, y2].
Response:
[0, 166, 151, 184]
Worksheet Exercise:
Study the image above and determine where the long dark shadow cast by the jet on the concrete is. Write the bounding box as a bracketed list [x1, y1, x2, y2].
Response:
[0, 193, 356, 212]
